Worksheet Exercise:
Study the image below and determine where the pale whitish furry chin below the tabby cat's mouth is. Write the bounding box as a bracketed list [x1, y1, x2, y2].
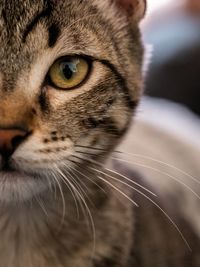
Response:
[0, 171, 47, 204]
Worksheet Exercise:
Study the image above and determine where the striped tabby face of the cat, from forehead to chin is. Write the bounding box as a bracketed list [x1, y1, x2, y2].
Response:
[0, 0, 144, 201]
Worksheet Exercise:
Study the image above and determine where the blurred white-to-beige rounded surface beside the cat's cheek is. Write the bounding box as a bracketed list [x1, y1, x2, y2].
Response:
[118, 97, 200, 235]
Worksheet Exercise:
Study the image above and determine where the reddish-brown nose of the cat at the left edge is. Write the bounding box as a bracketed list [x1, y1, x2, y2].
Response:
[0, 128, 29, 159]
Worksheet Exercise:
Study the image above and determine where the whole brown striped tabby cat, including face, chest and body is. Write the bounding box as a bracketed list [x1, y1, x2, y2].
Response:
[0, 0, 199, 267]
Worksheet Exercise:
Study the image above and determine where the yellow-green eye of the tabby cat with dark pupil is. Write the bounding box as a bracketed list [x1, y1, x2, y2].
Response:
[48, 56, 90, 90]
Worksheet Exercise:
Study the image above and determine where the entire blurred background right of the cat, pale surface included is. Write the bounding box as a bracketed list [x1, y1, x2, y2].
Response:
[117, 0, 200, 236]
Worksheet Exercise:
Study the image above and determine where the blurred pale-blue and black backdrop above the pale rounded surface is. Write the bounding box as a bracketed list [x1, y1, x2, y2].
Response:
[142, 0, 200, 115]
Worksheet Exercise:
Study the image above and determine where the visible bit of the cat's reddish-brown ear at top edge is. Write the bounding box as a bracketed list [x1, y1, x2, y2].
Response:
[114, 0, 147, 21]
